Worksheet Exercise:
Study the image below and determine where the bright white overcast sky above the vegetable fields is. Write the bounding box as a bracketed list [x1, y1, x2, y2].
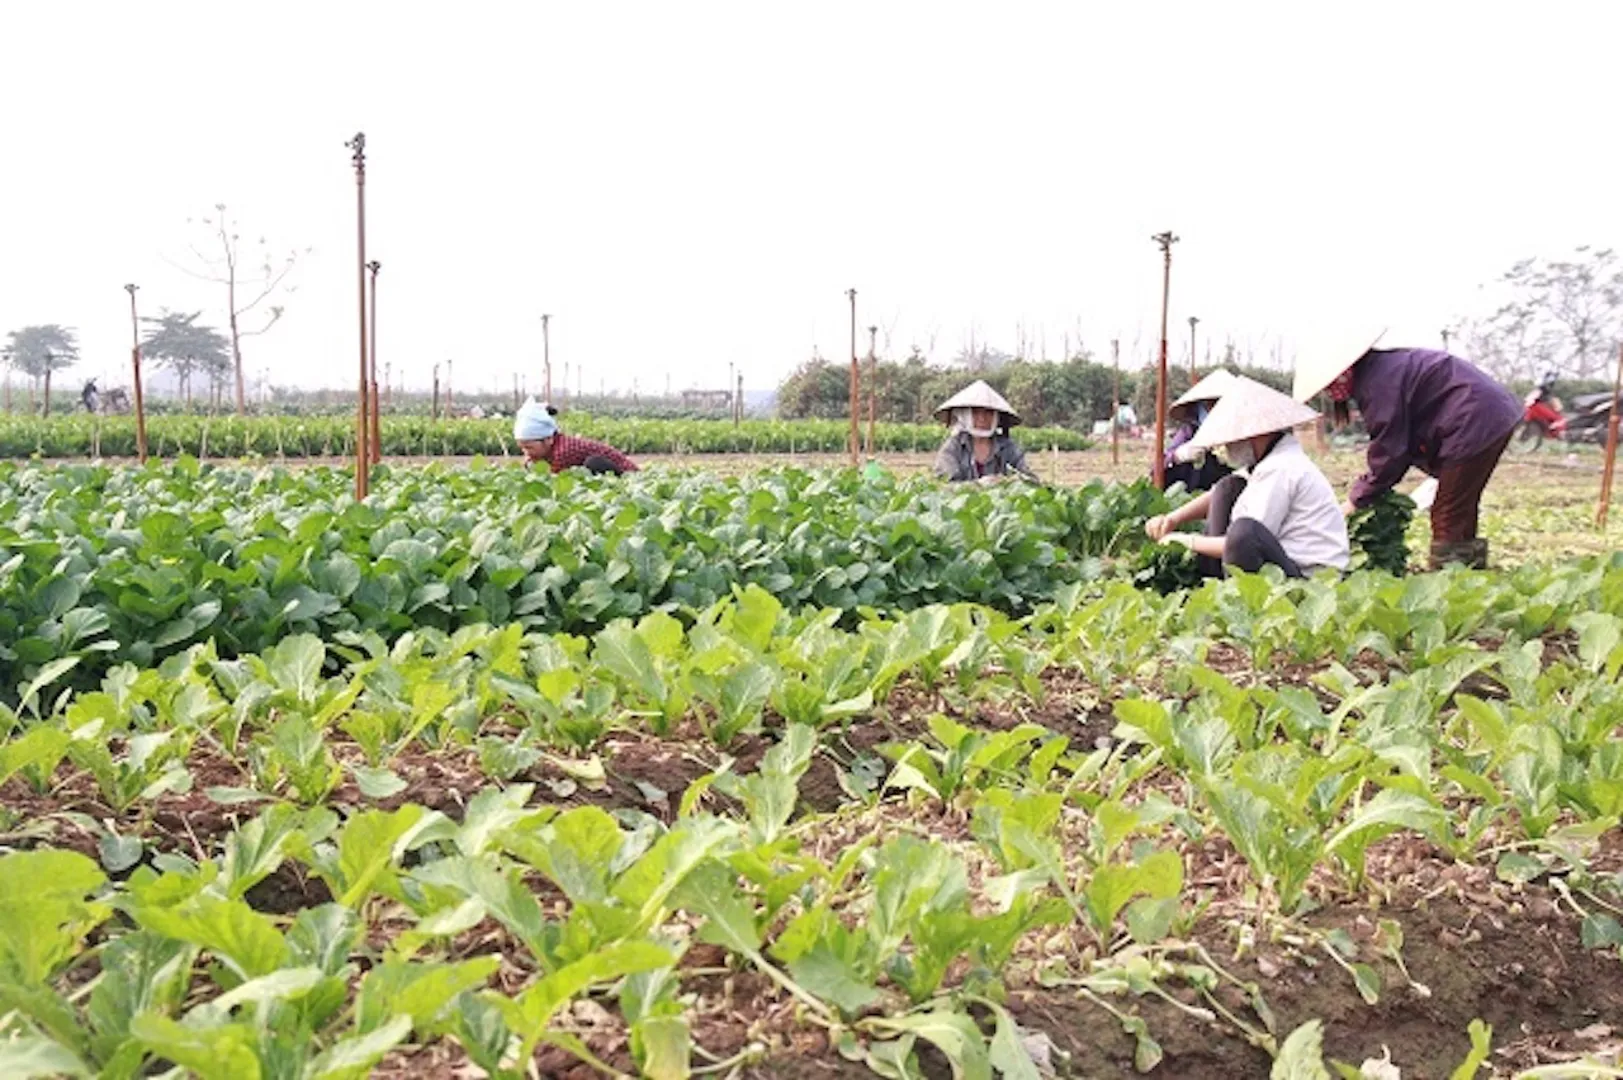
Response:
[0, 0, 1623, 391]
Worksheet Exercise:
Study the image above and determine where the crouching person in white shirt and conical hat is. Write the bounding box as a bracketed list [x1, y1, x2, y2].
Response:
[1144, 377, 1350, 578]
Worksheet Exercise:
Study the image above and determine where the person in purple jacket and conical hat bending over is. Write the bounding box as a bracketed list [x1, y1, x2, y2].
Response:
[1294, 335, 1522, 570]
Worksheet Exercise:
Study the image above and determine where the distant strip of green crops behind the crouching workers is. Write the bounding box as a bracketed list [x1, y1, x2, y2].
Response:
[0, 413, 1089, 460]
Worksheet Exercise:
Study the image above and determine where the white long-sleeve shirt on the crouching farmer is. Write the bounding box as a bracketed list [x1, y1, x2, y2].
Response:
[1230, 432, 1350, 573]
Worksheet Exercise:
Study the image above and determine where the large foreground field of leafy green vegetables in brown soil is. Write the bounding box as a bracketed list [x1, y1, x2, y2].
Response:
[0, 460, 1623, 1080]
